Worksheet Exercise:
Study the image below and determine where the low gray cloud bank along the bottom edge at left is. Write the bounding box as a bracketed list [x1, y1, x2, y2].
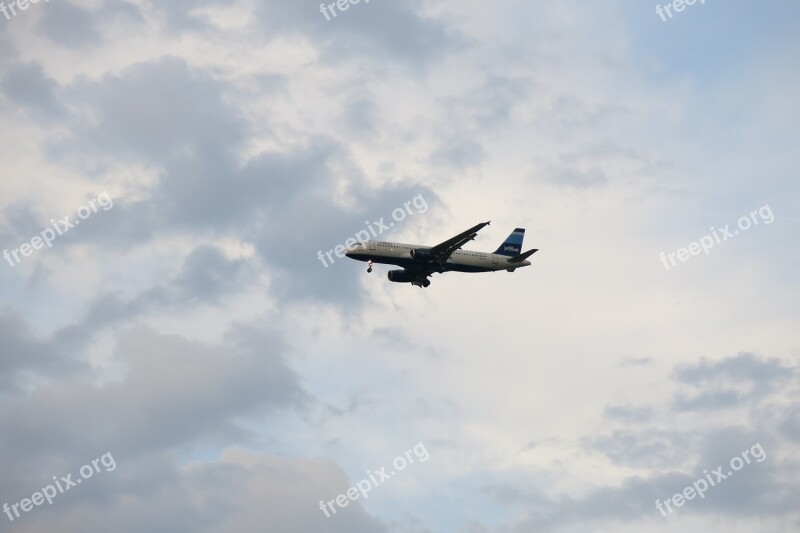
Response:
[3, 449, 388, 533]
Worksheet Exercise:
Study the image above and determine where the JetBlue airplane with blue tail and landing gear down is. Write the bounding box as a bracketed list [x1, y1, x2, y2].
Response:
[345, 221, 538, 288]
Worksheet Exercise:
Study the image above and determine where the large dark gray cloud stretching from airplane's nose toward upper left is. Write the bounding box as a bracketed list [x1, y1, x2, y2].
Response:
[0, 57, 437, 302]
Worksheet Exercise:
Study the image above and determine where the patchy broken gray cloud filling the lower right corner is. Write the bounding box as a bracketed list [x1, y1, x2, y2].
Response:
[506, 353, 800, 531]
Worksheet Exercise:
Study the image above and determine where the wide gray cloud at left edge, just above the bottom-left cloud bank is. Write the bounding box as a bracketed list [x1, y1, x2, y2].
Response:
[2, 329, 304, 463]
